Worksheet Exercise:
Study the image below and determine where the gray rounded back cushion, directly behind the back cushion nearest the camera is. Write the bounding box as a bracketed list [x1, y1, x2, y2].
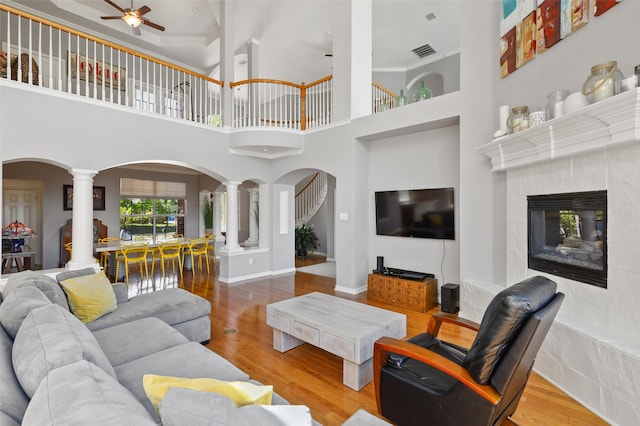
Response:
[13, 304, 116, 397]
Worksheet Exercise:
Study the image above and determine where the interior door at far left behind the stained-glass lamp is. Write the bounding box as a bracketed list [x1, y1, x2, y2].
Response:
[2, 179, 42, 268]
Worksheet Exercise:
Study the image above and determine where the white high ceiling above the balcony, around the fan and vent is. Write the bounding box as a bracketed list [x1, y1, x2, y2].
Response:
[6, 0, 462, 83]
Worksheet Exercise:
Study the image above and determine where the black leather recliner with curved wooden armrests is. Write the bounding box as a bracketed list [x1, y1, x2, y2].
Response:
[374, 276, 564, 426]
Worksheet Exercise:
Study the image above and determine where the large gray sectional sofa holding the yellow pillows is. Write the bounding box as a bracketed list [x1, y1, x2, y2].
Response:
[0, 268, 310, 426]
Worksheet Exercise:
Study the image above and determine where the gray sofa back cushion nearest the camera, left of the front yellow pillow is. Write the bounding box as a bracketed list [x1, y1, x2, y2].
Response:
[22, 360, 156, 426]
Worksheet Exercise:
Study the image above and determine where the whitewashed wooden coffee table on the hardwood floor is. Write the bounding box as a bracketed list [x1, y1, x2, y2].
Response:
[267, 292, 407, 391]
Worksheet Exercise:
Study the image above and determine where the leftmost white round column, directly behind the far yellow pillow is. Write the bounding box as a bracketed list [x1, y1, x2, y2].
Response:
[67, 169, 99, 270]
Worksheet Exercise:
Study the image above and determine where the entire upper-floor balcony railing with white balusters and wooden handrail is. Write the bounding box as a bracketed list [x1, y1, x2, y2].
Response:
[0, 4, 395, 130]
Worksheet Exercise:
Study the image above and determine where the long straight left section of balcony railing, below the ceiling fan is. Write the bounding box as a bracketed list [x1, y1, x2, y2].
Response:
[0, 4, 223, 125]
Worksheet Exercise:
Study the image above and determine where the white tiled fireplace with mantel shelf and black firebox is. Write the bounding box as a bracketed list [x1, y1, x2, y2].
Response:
[478, 89, 640, 425]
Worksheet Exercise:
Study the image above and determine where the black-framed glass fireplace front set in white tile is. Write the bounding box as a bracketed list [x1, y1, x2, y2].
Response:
[527, 191, 607, 288]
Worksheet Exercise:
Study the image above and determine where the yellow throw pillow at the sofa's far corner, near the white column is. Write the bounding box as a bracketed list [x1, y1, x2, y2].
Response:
[60, 272, 118, 323]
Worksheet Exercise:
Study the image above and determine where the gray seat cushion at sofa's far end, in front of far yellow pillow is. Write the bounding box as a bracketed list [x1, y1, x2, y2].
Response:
[82, 288, 211, 331]
